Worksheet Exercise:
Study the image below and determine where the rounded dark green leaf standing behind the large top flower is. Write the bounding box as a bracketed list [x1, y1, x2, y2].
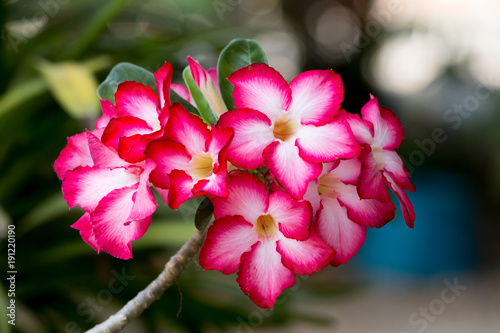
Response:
[217, 39, 267, 110]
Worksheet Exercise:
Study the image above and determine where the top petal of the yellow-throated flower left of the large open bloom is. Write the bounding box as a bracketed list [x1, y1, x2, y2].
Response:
[165, 103, 210, 156]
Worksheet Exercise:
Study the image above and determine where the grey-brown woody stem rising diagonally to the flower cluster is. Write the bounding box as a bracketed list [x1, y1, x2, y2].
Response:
[87, 230, 206, 333]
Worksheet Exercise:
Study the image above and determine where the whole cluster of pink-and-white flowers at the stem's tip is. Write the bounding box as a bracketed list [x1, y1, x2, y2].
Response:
[54, 58, 415, 307]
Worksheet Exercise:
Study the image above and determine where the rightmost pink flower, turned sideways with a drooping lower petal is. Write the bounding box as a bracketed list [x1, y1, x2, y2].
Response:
[341, 96, 415, 228]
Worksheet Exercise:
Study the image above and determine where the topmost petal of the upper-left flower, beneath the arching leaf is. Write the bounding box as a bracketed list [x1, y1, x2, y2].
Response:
[115, 81, 161, 131]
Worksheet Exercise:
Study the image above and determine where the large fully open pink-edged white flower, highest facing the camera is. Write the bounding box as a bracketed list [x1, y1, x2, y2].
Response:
[217, 64, 360, 199]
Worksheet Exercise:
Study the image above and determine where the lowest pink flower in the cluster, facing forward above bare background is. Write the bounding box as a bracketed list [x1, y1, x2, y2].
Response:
[200, 170, 335, 308]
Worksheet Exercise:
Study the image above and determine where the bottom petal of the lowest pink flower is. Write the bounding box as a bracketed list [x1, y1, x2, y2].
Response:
[236, 241, 295, 308]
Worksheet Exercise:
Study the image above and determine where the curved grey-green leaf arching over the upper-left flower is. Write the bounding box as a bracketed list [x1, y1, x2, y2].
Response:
[97, 62, 157, 103]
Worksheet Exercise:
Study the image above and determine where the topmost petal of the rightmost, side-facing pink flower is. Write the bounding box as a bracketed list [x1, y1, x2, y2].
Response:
[361, 97, 404, 150]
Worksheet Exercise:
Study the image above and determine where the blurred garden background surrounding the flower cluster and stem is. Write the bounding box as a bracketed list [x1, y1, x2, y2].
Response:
[0, 0, 500, 333]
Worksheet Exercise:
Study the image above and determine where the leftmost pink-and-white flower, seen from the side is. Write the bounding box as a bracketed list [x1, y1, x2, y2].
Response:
[54, 130, 156, 259]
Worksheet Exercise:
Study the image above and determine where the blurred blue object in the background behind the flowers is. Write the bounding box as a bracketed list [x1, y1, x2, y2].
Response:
[355, 170, 478, 276]
